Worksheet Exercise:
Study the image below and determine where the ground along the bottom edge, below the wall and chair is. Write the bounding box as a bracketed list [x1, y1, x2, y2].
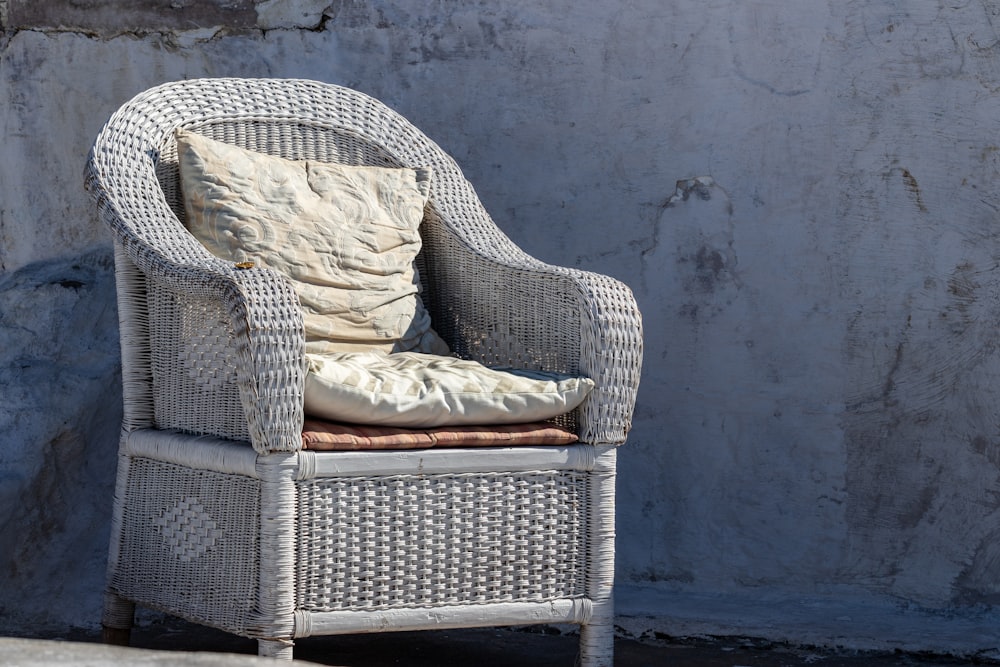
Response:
[0, 619, 1000, 667]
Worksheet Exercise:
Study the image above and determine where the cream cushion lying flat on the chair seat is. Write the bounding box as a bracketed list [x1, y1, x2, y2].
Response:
[305, 352, 594, 428]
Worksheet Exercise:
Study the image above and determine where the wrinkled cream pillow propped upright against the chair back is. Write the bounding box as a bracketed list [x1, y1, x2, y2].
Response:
[177, 129, 448, 354]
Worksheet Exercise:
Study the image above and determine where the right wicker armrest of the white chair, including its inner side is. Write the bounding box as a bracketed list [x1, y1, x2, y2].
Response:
[421, 208, 642, 445]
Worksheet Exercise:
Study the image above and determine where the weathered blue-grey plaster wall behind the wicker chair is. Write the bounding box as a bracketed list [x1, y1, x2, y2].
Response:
[0, 0, 1000, 652]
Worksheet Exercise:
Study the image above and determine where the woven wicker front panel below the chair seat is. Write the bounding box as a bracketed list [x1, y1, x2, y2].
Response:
[296, 471, 587, 611]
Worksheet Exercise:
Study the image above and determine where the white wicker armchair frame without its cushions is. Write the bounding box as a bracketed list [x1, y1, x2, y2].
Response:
[86, 79, 641, 665]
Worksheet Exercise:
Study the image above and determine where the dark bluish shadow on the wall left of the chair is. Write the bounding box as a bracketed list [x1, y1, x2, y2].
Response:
[0, 251, 121, 635]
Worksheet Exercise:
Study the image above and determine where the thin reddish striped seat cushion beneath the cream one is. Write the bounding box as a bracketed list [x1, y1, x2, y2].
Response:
[302, 419, 578, 451]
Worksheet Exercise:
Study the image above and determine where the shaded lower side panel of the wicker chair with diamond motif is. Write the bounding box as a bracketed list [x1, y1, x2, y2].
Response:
[111, 458, 260, 634]
